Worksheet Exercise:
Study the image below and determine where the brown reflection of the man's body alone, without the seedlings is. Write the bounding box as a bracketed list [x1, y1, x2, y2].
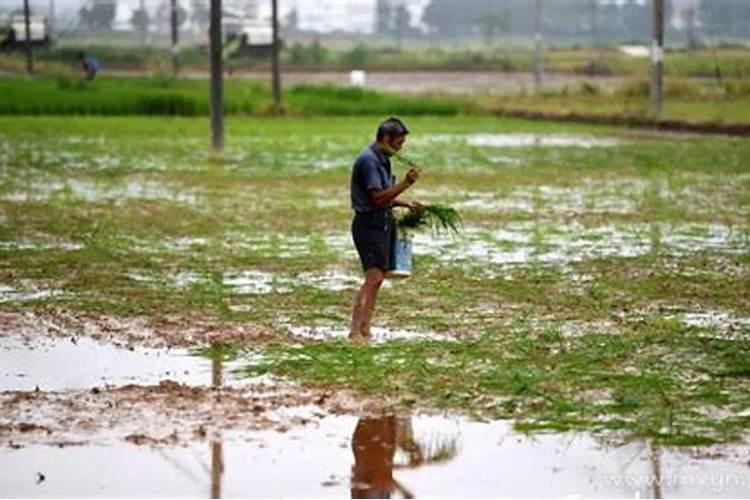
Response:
[351, 415, 414, 498]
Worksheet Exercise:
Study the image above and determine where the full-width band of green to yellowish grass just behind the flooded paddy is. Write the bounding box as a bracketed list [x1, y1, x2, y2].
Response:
[0, 76, 750, 128]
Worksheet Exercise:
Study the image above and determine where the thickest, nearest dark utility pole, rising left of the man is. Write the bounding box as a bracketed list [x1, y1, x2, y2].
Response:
[208, 0, 224, 155]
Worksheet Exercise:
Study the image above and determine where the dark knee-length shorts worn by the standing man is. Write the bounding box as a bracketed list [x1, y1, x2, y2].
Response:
[352, 209, 396, 272]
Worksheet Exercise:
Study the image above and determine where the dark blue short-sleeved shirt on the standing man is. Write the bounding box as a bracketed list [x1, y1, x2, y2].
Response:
[351, 144, 393, 213]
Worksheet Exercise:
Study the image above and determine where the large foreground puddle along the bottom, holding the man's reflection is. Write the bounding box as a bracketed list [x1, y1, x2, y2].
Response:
[0, 416, 750, 498]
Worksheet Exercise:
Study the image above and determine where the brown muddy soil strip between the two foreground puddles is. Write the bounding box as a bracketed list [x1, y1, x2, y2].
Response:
[0, 380, 383, 449]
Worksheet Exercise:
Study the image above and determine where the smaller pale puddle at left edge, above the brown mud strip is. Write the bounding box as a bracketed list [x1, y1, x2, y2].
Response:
[0, 337, 253, 391]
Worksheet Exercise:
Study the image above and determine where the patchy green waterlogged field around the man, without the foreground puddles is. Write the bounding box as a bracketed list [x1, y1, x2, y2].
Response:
[0, 116, 750, 445]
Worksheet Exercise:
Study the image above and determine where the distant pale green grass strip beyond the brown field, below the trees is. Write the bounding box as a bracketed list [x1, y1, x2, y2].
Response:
[8, 40, 750, 79]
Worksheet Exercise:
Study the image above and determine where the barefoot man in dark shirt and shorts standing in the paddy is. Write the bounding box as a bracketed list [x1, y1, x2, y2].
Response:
[349, 117, 422, 343]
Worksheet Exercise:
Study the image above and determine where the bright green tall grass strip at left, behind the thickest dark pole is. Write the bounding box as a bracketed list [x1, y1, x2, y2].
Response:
[0, 76, 469, 116]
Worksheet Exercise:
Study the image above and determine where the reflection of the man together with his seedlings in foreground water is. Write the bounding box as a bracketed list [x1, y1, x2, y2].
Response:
[351, 415, 458, 498]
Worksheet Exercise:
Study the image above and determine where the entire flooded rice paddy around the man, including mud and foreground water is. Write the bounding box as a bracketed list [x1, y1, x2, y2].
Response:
[0, 117, 750, 497]
